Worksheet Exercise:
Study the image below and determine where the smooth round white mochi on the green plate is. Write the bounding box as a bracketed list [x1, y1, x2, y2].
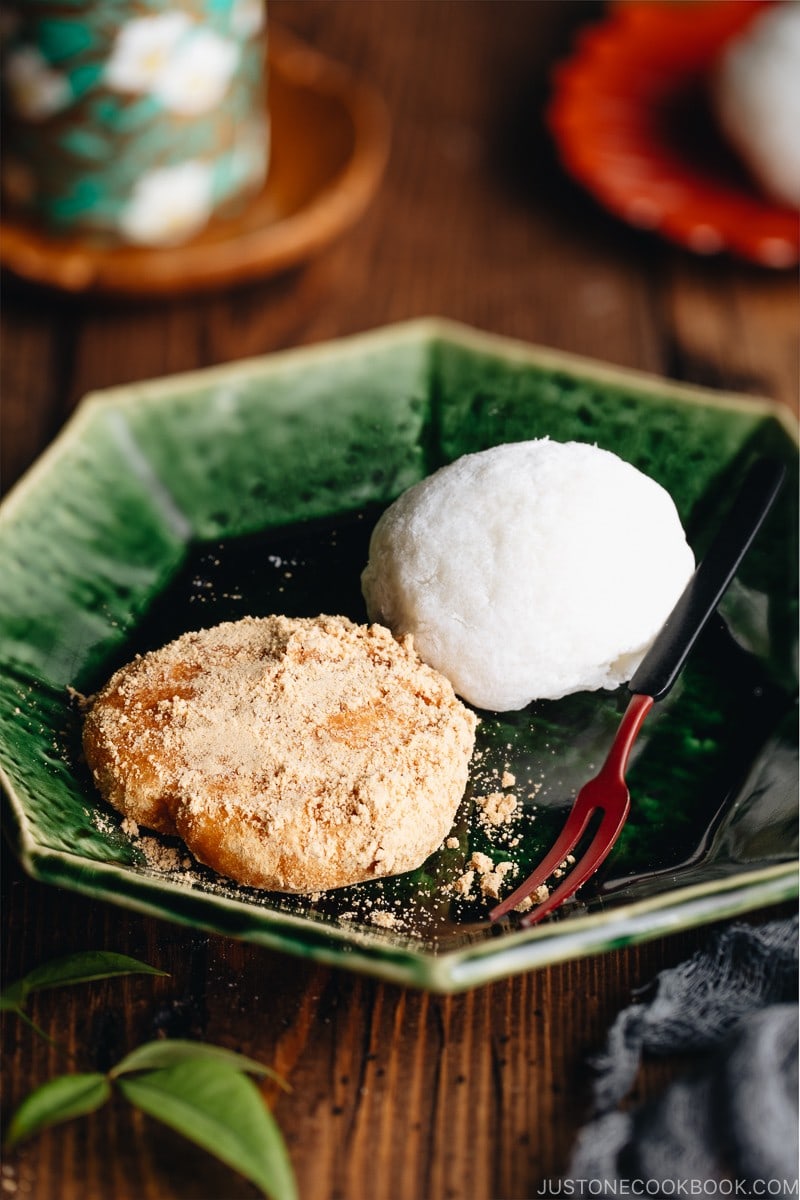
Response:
[361, 438, 694, 712]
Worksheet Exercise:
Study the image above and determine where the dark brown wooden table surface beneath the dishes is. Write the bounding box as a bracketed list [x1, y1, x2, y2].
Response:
[0, 0, 800, 1200]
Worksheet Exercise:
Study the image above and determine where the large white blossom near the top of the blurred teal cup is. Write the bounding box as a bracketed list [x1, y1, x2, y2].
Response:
[106, 12, 239, 116]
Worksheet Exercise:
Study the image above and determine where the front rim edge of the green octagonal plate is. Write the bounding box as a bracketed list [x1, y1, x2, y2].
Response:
[0, 816, 800, 995]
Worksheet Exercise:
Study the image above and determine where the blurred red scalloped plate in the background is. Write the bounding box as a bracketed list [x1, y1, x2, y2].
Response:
[547, 0, 800, 268]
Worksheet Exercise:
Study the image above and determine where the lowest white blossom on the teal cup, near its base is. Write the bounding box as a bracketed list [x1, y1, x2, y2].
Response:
[120, 160, 212, 246]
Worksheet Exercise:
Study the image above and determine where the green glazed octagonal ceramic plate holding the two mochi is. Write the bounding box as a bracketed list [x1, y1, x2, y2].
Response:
[0, 320, 798, 991]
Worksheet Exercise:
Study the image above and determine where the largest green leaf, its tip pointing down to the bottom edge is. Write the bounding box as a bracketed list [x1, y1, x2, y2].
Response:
[118, 1058, 297, 1200]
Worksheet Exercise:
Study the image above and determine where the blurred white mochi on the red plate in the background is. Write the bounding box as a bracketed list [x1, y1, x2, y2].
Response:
[712, 2, 800, 208]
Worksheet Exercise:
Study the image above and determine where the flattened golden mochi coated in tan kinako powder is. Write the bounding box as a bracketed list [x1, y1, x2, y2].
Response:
[84, 616, 476, 893]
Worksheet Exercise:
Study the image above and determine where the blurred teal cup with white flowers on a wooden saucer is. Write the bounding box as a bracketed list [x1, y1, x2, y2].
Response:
[1, 0, 269, 246]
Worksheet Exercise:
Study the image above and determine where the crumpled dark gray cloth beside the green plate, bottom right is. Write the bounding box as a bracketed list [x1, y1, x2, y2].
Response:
[561, 918, 799, 1196]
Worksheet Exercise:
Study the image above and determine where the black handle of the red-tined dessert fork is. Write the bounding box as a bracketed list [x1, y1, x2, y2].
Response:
[627, 458, 786, 700]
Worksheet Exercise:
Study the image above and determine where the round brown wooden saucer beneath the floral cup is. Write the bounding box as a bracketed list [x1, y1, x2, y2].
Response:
[0, 26, 389, 296]
